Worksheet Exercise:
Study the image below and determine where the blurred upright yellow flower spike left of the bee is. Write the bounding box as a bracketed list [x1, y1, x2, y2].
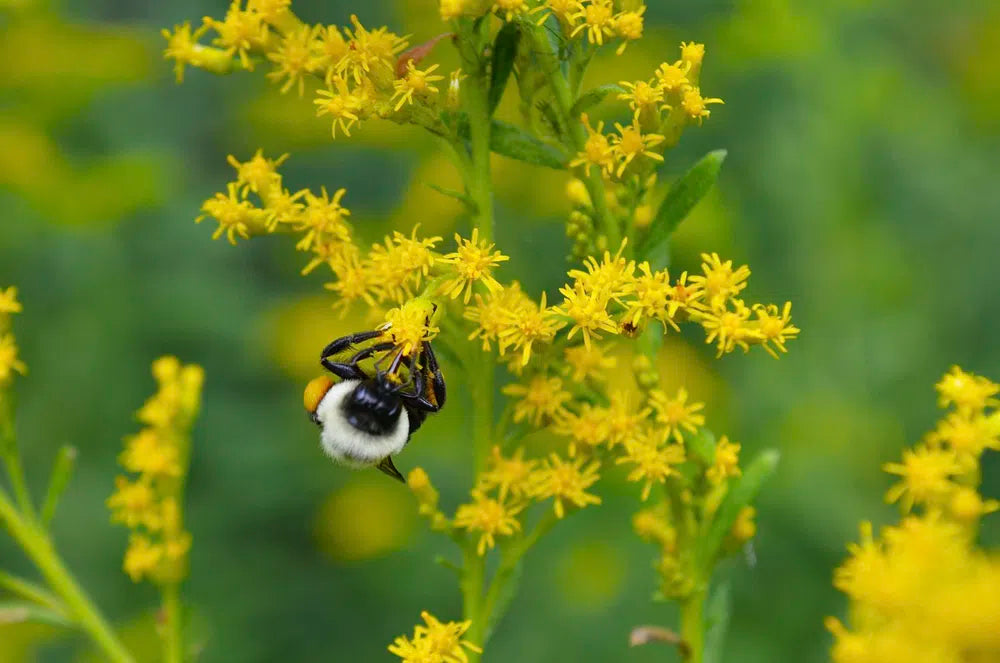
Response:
[107, 357, 204, 585]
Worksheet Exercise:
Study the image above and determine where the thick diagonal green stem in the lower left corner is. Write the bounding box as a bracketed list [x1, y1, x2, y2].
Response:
[0, 495, 135, 663]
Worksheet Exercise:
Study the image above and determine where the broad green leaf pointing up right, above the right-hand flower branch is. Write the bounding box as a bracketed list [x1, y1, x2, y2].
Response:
[636, 150, 726, 262]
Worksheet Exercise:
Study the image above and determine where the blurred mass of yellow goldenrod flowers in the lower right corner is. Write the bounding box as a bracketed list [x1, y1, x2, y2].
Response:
[827, 367, 1000, 663]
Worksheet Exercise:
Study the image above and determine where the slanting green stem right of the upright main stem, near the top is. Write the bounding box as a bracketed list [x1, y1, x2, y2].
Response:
[531, 27, 622, 251]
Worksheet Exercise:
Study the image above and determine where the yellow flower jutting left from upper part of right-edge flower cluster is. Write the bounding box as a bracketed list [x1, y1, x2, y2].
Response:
[882, 445, 962, 513]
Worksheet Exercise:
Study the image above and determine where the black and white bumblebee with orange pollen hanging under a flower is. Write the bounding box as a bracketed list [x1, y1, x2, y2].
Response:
[304, 327, 445, 483]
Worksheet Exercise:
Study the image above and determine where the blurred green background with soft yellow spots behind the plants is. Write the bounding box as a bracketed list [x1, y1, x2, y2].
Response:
[0, 0, 1000, 663]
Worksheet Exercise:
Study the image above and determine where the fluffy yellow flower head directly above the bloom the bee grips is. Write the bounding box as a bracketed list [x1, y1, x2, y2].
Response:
[368, 224, 441, 302]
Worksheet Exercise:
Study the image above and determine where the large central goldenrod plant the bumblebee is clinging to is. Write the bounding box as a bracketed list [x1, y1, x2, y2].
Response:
[164, 0, 799, 663]
